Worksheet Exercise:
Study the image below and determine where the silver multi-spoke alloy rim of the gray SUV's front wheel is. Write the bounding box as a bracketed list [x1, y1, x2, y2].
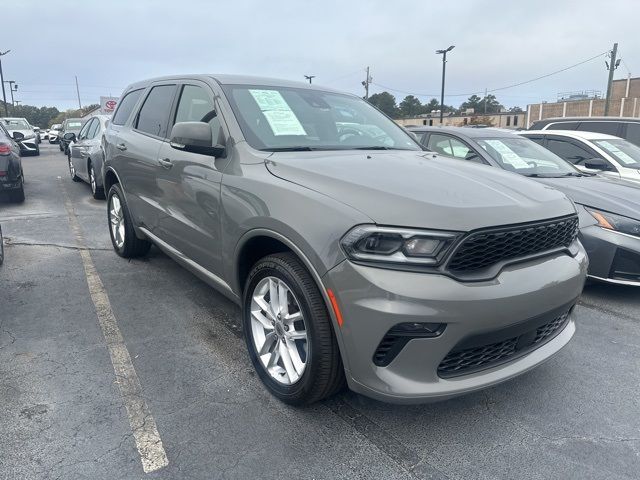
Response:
[251, 277, 309, 385]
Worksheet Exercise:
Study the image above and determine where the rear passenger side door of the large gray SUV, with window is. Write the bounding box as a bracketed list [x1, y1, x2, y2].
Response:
[115, 82, 177, 233]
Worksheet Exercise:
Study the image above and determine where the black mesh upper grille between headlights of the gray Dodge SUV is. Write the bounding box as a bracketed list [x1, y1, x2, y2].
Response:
[448, 216, 578, 272]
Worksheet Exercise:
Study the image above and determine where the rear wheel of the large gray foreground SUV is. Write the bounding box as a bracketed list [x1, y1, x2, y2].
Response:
[107, 183, 151, 258]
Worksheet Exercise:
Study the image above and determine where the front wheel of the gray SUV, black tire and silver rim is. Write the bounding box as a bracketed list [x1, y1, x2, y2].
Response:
[242, 253, 344, 405]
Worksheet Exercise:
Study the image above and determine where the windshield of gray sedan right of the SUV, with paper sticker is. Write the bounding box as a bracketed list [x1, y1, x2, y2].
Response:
[477, 138, 580, 177]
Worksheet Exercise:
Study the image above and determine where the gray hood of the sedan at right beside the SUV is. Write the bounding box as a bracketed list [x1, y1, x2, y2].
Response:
[536, 176, 640, 220]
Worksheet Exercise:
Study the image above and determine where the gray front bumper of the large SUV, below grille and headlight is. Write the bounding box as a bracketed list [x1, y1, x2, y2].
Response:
[323, 242, 588, 403]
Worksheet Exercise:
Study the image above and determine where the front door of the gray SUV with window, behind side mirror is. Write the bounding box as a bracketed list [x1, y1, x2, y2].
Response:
[158, 81, 228, 275]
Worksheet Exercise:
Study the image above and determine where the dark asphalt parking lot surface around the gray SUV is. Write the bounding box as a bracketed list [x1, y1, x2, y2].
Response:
[0, 142, 640, 479]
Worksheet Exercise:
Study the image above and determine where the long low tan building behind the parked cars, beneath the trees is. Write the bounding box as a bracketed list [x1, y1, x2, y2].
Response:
[396, 112, 526, 130]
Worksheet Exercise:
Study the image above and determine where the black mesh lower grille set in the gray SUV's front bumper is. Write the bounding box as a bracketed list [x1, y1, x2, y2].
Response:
[438, 312, 569, 378]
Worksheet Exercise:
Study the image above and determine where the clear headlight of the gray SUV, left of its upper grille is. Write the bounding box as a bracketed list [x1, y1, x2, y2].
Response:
[340, 225, 460, 266]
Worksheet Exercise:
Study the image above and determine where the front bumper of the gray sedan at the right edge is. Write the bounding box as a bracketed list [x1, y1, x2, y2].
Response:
[580, 225, 640, 286]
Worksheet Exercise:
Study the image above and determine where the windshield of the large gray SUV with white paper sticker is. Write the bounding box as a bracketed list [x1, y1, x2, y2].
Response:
[223, 85, 422, 151]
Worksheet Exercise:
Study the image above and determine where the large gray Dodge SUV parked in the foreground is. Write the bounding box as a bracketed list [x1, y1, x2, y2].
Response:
[104, 75, 587, 404]
